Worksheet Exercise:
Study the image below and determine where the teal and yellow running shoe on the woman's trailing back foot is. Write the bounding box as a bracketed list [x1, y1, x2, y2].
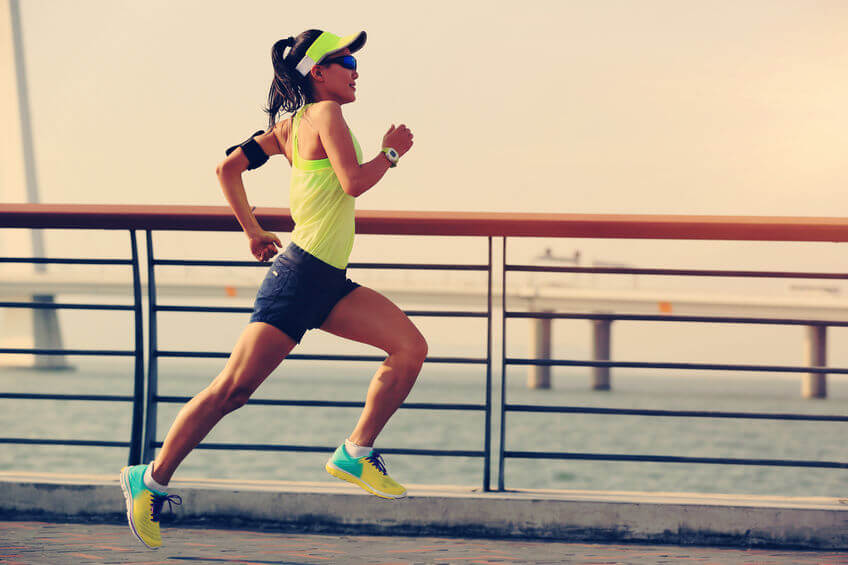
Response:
[121, 465, 183, 549]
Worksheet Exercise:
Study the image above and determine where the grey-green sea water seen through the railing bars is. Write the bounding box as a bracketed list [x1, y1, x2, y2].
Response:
[0, 352, 848, 496]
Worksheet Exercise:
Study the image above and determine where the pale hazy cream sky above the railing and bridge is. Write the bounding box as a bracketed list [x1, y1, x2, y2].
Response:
[0, 0, 848, 269]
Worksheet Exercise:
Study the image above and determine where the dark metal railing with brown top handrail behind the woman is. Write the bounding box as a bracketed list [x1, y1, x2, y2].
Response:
[0, 205, 848, 490]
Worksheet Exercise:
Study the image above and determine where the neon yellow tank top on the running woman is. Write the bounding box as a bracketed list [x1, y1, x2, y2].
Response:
[289, 104, 362, 269]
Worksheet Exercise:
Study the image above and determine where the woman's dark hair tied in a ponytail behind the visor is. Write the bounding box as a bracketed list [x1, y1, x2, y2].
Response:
[265, 29, 321, 130]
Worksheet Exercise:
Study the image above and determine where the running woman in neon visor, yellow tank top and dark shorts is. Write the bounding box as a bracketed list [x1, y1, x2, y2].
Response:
[121, 30, 427, 548]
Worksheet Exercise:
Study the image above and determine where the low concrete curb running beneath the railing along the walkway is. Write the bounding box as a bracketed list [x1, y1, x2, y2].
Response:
[0, 472, 848, 549]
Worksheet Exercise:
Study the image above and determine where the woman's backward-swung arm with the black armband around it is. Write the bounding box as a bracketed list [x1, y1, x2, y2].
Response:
[215, 132, 283, 261]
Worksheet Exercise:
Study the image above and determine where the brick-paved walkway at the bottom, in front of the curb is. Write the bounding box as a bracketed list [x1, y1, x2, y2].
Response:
[0, 522, 848, 565]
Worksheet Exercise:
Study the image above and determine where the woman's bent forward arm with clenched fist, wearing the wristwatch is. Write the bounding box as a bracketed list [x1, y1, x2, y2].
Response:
[311, 101, 412, 196]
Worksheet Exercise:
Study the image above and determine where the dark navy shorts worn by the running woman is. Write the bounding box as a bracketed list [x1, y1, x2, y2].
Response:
[250, 243, 359, 343]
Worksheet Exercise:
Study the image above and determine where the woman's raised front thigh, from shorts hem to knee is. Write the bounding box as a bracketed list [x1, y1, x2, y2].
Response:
[321, 286, 426, 354]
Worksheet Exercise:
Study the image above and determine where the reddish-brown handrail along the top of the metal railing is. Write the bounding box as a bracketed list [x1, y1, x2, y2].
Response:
[0, 204, 848, 242]
